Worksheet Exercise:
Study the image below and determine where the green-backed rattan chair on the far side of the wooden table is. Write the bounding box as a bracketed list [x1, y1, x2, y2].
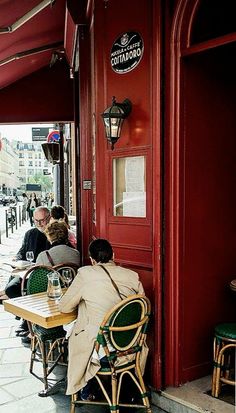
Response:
[21, 265, 66, 395]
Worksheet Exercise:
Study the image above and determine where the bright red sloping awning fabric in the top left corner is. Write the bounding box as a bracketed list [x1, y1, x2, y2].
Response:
[0, 0, 65, 88]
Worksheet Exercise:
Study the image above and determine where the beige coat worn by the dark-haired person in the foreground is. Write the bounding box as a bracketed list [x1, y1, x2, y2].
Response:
[59, 262, 144, 394]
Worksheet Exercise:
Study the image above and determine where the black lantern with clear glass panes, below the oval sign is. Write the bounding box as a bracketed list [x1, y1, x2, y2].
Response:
[101, 96, 132, 150]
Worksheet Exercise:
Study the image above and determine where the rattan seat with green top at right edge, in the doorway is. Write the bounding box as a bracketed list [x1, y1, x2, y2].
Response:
[212, 323, 236, 397]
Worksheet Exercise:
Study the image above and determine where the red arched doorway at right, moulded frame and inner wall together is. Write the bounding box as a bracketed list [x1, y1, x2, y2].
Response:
[166, 1, 236, 385]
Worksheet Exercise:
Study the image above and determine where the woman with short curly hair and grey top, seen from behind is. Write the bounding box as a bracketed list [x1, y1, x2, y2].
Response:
[36, 221, 80, 266]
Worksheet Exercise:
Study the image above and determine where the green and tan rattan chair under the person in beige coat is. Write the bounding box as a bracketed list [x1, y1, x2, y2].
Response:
[71, 295, 151, 413]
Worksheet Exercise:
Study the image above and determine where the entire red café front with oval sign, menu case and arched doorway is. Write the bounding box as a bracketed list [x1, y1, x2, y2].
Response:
[0, 0, 236, 389]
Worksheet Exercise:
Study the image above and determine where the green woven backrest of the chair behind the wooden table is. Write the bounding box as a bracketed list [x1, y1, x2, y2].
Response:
[21, 265, 52, 295]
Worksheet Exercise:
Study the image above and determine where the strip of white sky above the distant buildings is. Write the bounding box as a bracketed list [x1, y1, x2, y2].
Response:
[0, 123, 53, 142]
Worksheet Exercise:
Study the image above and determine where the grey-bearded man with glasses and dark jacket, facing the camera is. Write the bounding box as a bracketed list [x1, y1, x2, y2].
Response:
[0, 206, 51, 334]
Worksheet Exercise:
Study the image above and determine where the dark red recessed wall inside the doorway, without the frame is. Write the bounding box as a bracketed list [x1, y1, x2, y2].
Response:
[180, 46, 236, 381]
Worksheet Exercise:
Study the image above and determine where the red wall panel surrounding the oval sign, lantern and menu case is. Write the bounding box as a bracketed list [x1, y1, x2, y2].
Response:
[94, 0, 156, 285]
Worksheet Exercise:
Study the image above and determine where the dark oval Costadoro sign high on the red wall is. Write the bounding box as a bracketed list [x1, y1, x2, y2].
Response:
[111, 32, 144, 73]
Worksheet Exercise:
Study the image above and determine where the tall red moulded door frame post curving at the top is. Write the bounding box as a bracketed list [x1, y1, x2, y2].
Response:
[165, 0, 199, 386]
